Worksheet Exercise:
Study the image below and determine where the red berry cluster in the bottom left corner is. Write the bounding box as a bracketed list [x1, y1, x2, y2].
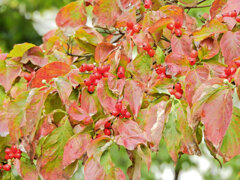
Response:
[0, 145, 22, 171]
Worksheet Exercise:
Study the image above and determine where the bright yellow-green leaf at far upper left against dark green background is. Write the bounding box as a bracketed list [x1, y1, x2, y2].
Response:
[8, 43, 35, 58]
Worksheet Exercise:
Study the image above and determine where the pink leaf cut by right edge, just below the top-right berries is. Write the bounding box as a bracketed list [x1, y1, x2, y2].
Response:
[220, 31, 240, 64]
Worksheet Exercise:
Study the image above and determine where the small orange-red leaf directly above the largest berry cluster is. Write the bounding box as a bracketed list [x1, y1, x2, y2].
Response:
[95, 42, 116, 63]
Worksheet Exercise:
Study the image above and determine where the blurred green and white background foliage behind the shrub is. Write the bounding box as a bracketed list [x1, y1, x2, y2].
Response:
[0, 0, 240, 180]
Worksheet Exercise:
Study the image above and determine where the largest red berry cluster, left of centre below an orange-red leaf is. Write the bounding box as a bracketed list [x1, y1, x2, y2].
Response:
[79, 64, 110, 93]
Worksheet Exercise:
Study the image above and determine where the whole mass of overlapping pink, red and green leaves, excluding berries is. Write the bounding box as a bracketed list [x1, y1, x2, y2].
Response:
[0, 0, 240, 180]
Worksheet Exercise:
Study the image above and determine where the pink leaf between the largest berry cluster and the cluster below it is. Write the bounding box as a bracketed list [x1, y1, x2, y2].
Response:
[97, 79, 117, 113]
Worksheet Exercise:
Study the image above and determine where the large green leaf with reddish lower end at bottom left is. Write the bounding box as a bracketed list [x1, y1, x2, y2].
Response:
[37, 117, 73, 180]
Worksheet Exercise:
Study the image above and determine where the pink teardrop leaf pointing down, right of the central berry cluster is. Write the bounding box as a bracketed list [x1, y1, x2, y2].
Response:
[124, 80, 143, 119]
